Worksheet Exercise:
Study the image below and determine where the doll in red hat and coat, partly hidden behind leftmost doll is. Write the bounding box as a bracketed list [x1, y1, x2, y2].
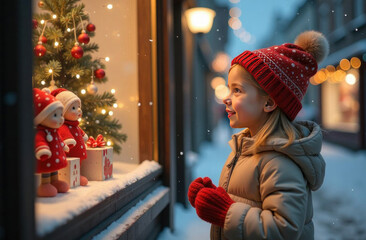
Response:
[51, 88, 88, 186]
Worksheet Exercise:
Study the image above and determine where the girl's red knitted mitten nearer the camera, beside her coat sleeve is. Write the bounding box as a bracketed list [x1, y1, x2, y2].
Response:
[195, 187, 234, 227]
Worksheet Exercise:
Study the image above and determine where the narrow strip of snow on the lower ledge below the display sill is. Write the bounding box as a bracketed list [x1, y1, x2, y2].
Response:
[93, 186, 169, 240]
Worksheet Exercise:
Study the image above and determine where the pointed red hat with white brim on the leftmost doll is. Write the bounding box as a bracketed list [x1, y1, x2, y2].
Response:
[33, 88, 64, 125]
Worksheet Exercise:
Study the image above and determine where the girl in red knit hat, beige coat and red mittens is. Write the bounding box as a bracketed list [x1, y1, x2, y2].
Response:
[188, 31, 328, 240]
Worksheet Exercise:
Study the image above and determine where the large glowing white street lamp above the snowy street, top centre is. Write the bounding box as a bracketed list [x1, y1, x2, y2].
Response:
[184, 7, 216, 33]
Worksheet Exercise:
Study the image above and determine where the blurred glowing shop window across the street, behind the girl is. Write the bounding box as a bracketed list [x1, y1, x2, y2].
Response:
[311, 57, 361, 133]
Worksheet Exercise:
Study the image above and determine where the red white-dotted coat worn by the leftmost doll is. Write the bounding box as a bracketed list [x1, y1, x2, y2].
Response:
[35, 125, 67, 173]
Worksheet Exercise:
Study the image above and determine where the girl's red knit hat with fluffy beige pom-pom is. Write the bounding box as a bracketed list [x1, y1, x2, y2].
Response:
[231, 31, 329, 121]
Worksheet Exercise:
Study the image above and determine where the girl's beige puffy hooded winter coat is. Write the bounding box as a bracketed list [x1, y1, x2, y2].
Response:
[211, 121, 325, 240]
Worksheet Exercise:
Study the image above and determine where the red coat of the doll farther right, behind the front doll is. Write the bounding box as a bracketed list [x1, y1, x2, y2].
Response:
[59, 120, 86, 161]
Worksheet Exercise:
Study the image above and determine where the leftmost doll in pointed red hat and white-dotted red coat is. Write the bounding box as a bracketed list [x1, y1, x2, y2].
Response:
[33, 88, 69, 197]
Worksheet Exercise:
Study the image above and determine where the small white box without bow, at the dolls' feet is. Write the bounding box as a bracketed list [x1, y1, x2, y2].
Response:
[58, 157, 80, 188]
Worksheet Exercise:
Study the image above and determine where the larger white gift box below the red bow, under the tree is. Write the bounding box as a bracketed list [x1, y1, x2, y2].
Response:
[81, 147, 113, 181]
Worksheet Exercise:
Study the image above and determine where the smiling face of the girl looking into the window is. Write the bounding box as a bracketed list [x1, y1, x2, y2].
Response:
[223, 66, 266, 136]
